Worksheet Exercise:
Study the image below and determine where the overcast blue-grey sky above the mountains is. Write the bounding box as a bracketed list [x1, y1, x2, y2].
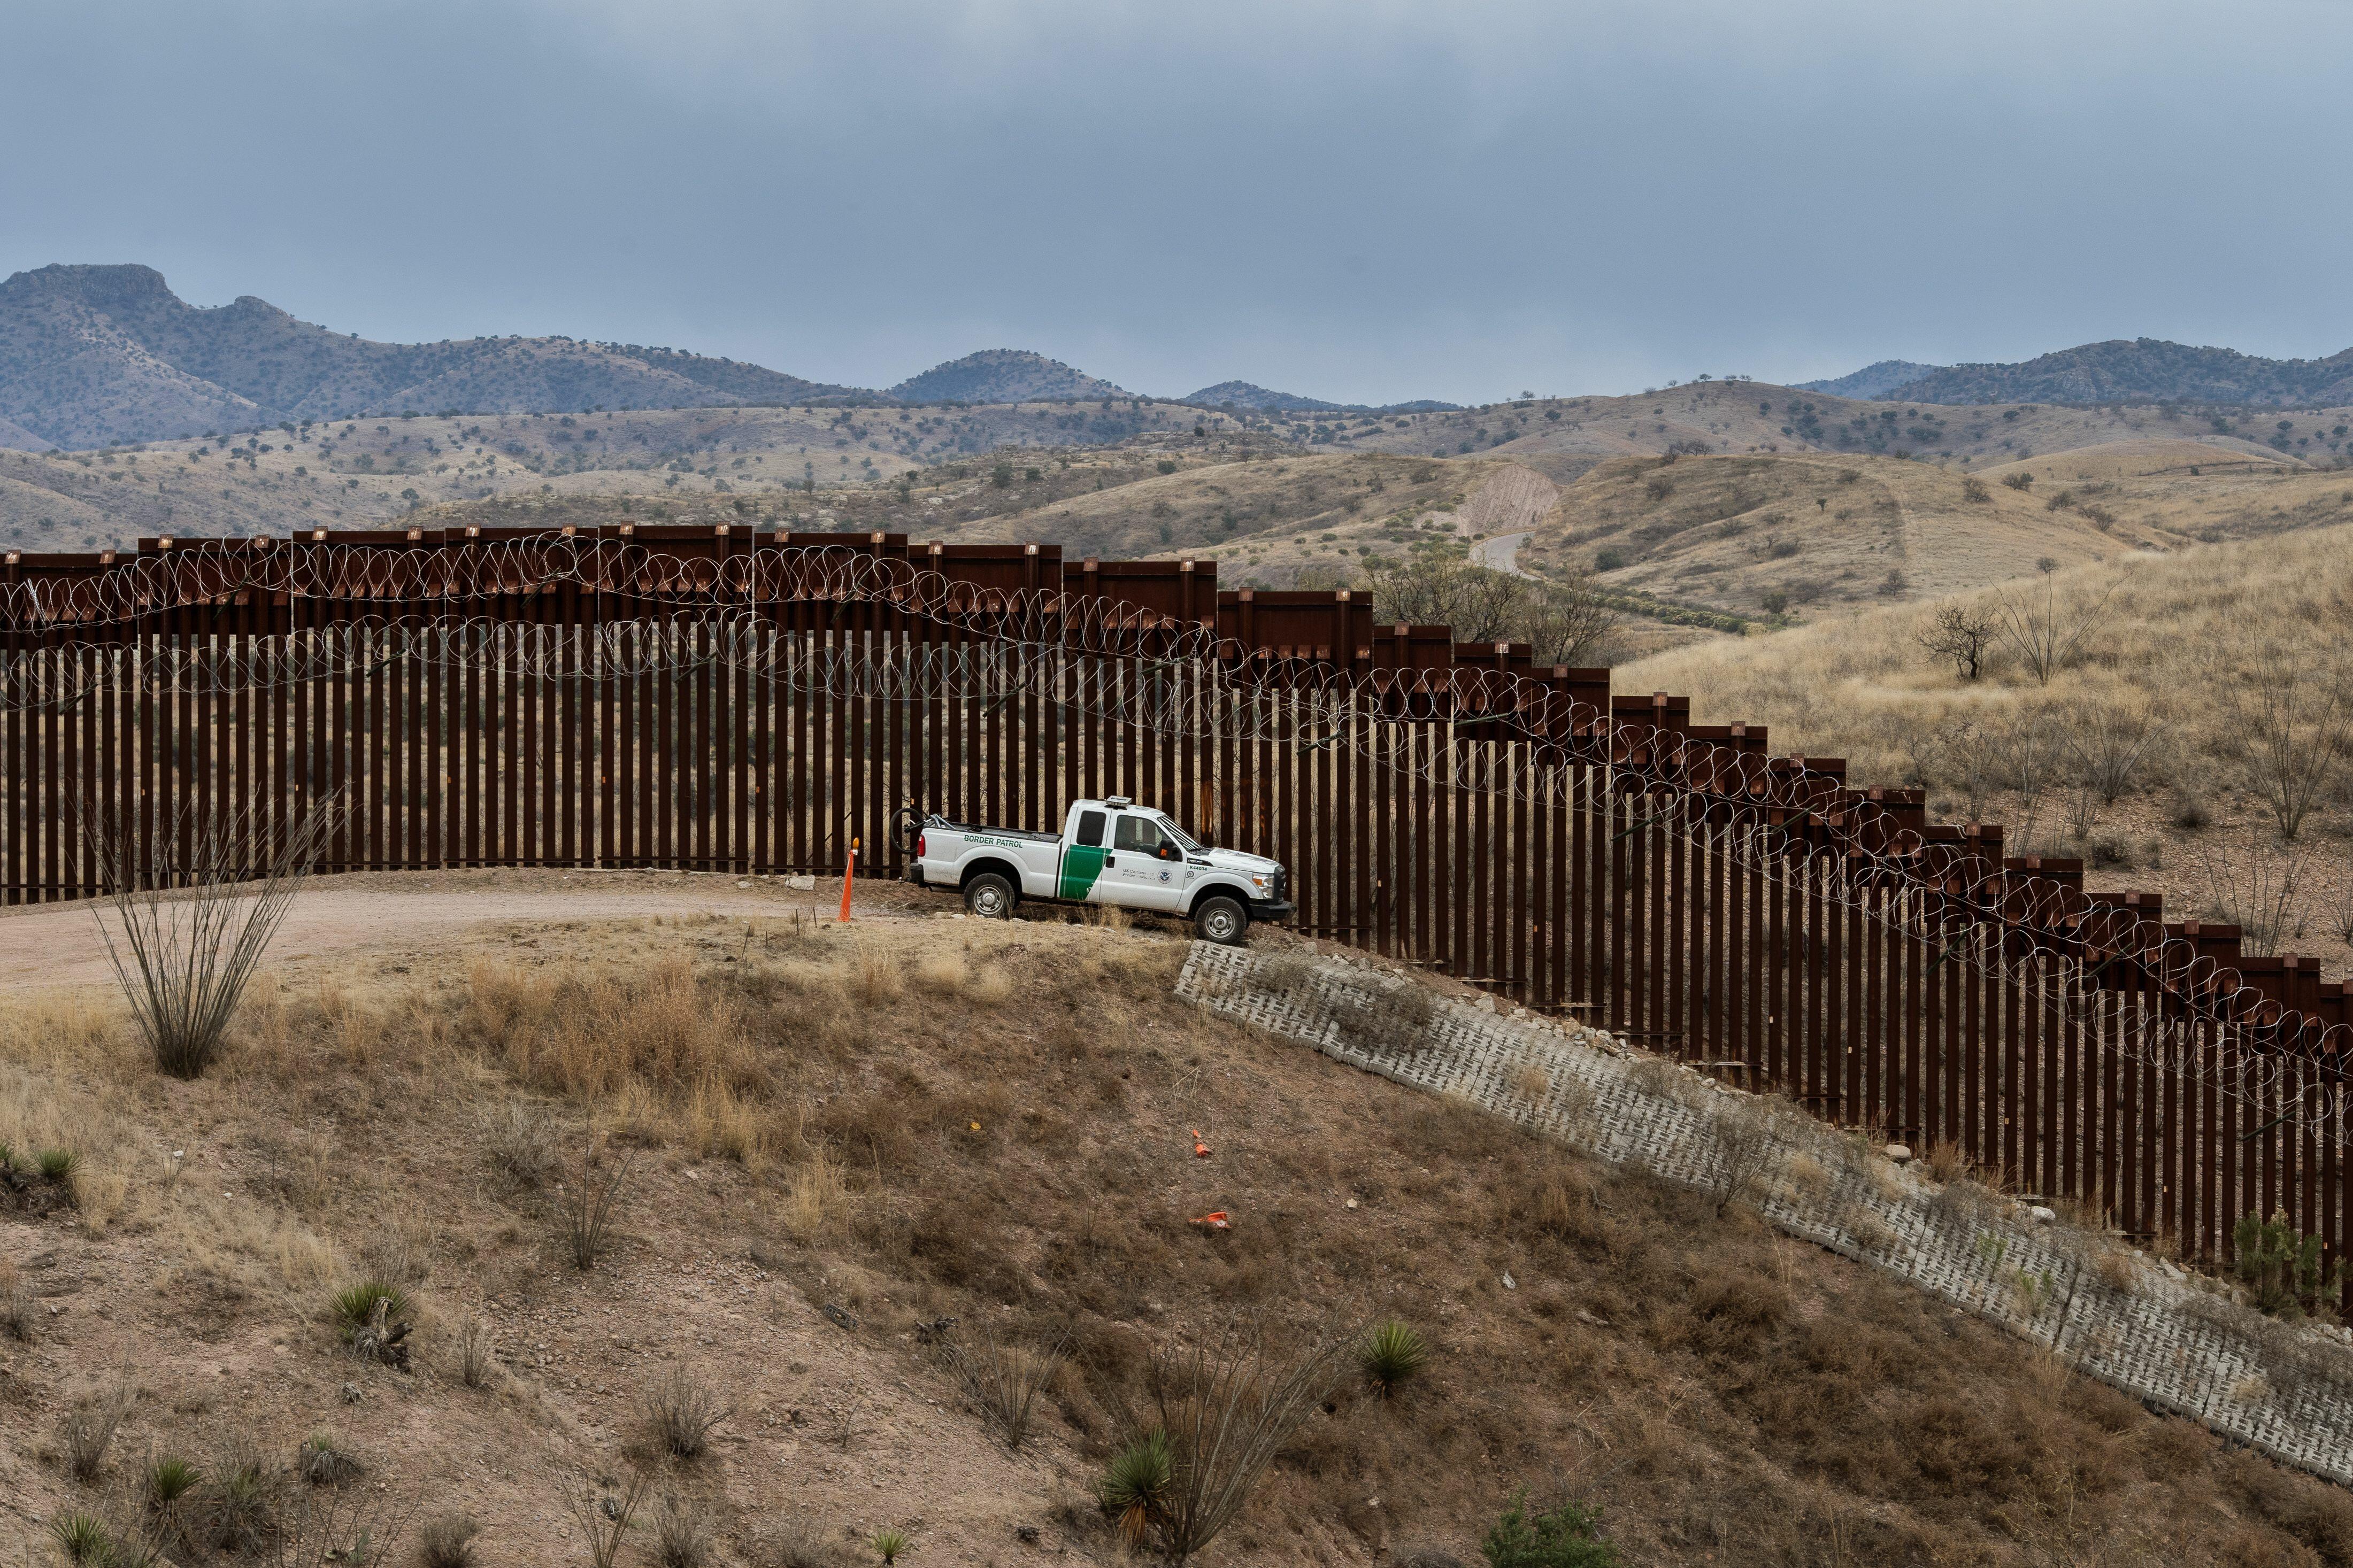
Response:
[0, 0, 2353, 402]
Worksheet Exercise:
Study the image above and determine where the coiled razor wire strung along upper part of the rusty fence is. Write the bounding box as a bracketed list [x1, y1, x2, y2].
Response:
[0, 534, 2353, 1145]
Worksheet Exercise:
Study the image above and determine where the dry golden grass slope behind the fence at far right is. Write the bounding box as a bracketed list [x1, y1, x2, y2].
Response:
[1621, 527, 2353, 893]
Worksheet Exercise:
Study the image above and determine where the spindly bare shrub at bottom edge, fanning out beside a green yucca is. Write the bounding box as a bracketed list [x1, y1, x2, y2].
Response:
[1139, 1333, 1343, 1563]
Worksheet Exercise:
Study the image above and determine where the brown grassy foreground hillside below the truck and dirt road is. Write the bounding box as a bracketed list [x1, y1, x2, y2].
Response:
[0, 875, 2353, 1568]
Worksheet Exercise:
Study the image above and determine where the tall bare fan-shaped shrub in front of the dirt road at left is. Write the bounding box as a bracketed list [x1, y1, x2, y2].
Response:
[84, 801, 341, 1079]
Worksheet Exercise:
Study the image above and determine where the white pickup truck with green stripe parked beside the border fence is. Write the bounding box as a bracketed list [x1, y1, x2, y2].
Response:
[906, 794, 1292, 947]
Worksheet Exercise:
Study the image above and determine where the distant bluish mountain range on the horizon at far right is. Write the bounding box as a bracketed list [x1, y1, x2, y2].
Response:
[1798, 338, 2353, 409]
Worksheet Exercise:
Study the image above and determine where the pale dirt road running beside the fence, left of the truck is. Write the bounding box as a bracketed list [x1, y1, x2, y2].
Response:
[0, 870, 922, 992]
